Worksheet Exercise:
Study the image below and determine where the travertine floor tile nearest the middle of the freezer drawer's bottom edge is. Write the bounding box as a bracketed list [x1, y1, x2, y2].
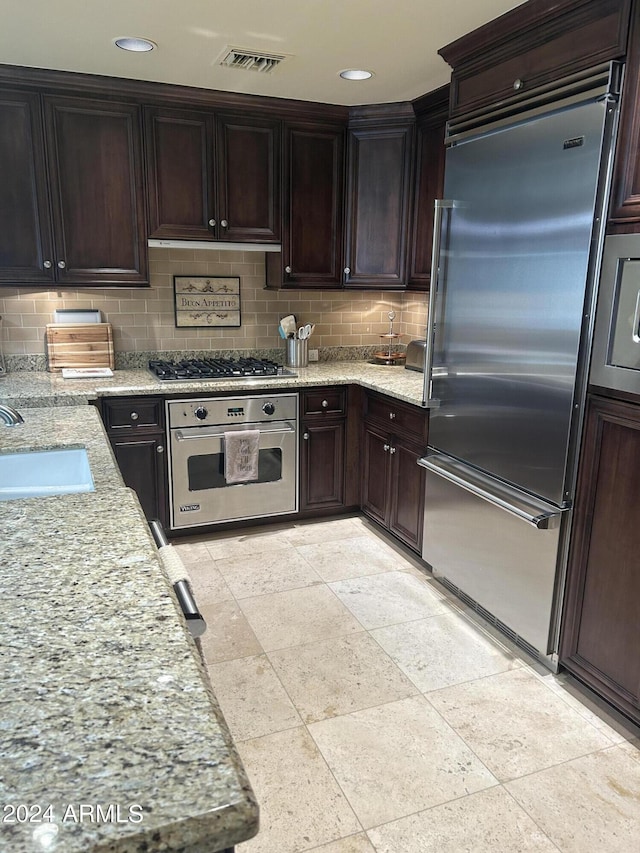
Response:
[371, 605, 521, 693]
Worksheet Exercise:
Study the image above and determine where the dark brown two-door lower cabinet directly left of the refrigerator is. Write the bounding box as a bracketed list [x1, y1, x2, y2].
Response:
[361, 394, 428, 553]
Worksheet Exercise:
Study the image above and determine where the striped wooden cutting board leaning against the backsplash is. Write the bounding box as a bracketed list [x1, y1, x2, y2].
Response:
[45, 323, 115, 372]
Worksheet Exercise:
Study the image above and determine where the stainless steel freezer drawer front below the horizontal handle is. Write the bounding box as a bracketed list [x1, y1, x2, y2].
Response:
[422, 471, 561, 655]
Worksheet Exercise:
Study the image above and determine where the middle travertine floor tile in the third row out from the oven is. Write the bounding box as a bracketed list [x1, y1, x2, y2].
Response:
[239, 585, 362, 652]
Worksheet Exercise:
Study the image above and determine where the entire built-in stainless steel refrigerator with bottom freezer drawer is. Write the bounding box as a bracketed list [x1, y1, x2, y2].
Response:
[419, 63, 620, 668]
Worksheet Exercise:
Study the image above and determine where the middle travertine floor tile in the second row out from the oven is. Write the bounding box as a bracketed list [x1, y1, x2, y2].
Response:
[215, 545, 322, 598]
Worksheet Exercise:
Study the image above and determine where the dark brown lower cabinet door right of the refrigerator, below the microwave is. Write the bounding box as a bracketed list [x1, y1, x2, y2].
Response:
[560, 396, 640, 723]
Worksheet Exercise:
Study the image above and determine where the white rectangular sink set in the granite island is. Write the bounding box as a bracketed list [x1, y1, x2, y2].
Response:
[0, 447, 95, 501]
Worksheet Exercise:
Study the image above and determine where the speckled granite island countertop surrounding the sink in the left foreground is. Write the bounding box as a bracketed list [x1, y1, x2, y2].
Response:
[0, 408, 258, 853]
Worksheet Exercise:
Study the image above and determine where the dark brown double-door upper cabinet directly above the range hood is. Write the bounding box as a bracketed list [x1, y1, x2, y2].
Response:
[145, 107, 280, 243]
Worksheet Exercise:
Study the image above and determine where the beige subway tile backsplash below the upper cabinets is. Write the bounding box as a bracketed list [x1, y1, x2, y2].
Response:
[0, 248, 427, 356]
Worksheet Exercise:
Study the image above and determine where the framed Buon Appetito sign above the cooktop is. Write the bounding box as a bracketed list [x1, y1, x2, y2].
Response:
[173, 275, 241, 328]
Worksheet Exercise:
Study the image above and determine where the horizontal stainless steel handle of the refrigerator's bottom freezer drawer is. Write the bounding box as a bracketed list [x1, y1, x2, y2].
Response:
[418, 452, 569, 530]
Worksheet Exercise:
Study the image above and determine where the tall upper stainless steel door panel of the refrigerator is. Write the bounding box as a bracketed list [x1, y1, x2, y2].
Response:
[429, 102, 605, 504]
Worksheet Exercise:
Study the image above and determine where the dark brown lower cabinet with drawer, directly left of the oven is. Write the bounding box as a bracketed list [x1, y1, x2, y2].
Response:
[102, 397, 168, 525]
